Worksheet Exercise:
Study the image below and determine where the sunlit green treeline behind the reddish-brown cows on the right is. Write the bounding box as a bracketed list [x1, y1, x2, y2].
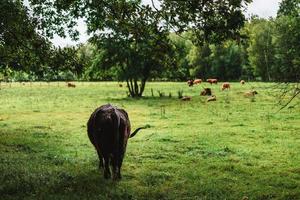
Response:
[165, 14, 300, 82]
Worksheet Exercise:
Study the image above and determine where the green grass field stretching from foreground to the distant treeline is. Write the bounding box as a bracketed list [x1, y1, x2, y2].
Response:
[0, 82, 300, 200]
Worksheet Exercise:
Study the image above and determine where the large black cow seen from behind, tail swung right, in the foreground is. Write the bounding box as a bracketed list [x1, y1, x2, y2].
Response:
[87, 104, 149, 180]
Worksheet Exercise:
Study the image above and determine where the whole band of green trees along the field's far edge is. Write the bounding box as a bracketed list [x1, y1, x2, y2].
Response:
[0, 0, 300, 82]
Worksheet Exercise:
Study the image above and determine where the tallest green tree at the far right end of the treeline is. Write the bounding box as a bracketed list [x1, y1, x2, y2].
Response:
[274, 0, 300, 82]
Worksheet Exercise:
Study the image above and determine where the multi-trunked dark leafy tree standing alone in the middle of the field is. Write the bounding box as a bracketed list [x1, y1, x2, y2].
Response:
[92, 5, 173, 97]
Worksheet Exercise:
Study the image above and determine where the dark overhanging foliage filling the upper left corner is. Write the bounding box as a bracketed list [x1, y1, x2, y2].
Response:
[0, 0, 86, 80]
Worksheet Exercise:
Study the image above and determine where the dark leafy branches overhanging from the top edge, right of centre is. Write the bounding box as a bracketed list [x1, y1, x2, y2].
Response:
[160, 0, 252, 44]
